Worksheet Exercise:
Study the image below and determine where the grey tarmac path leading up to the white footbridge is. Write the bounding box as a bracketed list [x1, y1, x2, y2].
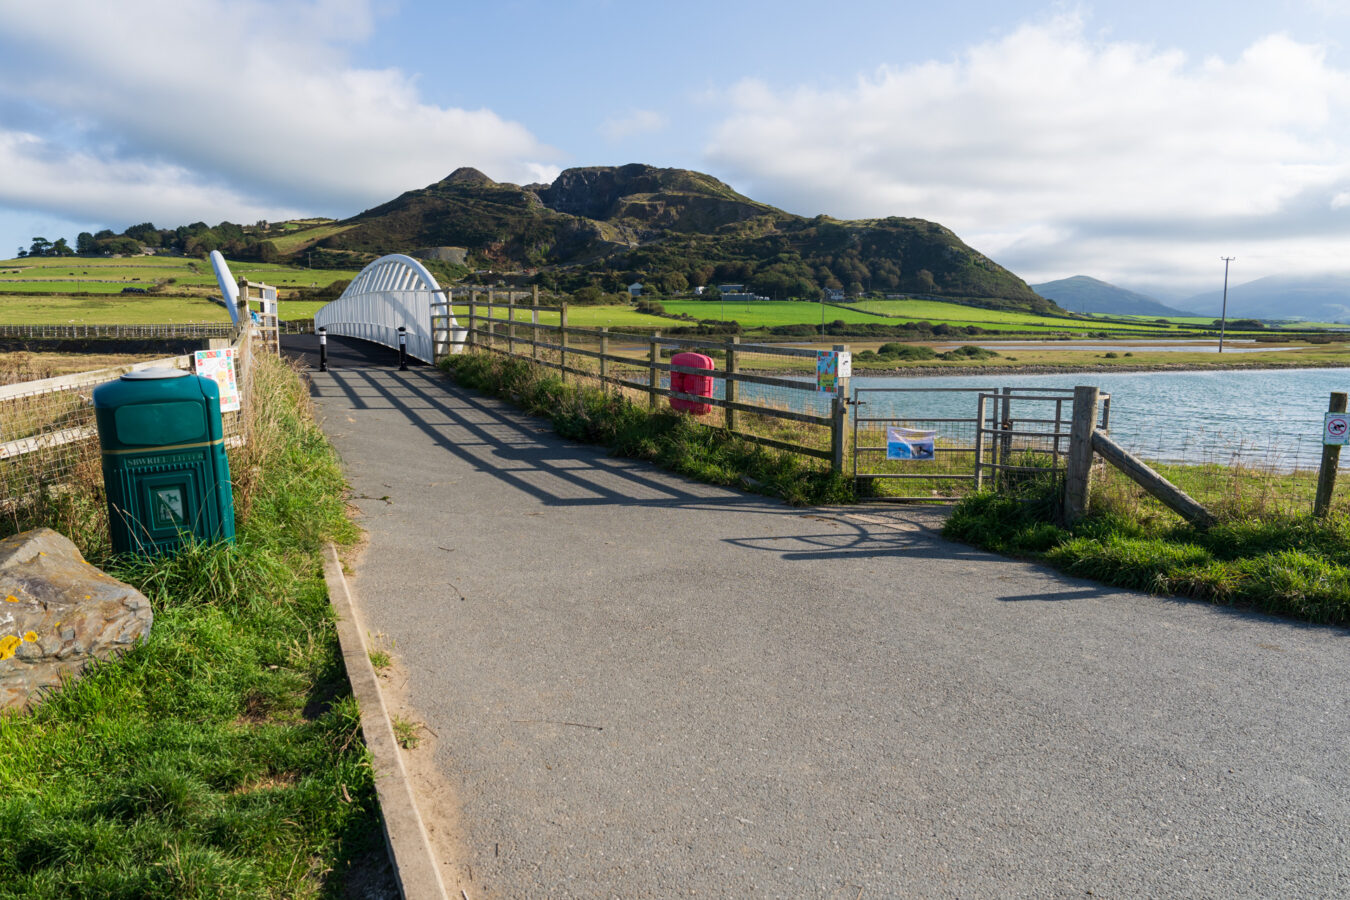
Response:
[295, 340, 1350, 900]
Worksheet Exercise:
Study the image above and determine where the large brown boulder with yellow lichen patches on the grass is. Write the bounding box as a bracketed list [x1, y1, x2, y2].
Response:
[0, 528, 154, 711]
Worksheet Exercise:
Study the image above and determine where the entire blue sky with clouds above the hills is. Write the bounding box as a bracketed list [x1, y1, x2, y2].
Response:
[0, 0, 1350, 300]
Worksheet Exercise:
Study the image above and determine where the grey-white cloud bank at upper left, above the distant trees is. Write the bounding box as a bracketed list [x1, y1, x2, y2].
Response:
[0, 0, 556, 232]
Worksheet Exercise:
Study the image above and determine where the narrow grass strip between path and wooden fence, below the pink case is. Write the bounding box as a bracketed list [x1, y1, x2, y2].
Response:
[440, 354, 857, 506]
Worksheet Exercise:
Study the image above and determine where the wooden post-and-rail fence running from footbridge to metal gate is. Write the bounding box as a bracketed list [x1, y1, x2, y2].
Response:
[459, 294, 848, 471]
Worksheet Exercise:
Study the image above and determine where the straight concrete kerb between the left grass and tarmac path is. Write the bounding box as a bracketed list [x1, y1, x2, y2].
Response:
[324, 544, 448, 900]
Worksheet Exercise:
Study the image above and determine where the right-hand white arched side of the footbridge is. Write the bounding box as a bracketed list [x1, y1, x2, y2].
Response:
[315, 254, 460, 363]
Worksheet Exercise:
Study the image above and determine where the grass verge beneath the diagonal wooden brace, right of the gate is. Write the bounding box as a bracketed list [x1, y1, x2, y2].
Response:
[942, 484, 1350, 625]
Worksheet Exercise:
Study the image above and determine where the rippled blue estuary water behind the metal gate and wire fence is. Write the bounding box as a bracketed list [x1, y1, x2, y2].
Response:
[852, 368, 1350, 470]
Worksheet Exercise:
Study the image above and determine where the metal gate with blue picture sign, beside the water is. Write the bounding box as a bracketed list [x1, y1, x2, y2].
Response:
[849, 387, 1111, 502]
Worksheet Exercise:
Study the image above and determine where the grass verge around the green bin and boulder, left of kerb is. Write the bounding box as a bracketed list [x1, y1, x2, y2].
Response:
[0, 358, 383, 897]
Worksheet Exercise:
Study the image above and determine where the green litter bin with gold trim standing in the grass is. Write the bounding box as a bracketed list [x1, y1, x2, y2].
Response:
[93, 368, 235, 555]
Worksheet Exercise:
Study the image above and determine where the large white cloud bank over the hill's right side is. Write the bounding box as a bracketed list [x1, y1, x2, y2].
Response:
[707, 18, 1350, 288]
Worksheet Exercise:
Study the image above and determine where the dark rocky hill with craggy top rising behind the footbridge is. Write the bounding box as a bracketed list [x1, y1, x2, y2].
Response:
[310, 165, 1057, 312]
